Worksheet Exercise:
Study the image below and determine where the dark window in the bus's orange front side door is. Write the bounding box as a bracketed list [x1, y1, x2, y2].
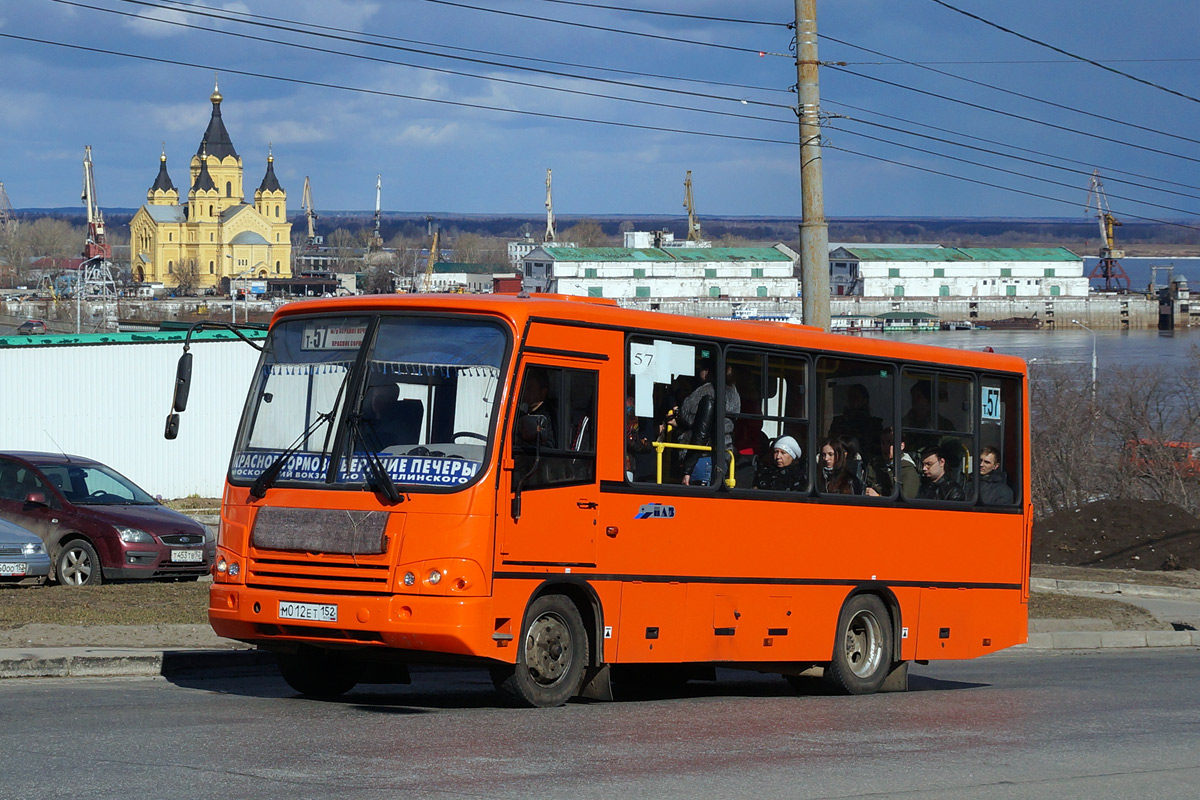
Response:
[512, 365, 599, 491]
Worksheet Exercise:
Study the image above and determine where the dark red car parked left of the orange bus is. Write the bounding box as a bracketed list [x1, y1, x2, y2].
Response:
[0, 452, 216, 587]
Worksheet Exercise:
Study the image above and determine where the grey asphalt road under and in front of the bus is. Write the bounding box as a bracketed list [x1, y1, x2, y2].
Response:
[0, 649, 1200, 800]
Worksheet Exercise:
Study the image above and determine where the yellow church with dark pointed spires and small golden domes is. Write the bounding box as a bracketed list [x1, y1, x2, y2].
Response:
[130, 83, 292, 290]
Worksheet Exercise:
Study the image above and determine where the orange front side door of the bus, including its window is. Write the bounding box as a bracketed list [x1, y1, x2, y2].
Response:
[497, 357, 600, 570]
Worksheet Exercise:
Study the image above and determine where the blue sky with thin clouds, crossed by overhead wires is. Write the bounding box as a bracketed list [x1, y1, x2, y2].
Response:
[0, 0, 1200, 222]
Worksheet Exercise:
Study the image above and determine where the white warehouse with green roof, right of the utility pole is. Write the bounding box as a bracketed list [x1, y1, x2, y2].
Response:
[829, 246, 1088, 297]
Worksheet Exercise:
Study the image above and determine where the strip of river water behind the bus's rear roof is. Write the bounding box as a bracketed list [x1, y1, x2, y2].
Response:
[872, 325, 1200, 377]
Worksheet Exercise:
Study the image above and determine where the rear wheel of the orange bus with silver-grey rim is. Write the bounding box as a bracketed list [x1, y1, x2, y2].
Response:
[826, 595, 892, 694]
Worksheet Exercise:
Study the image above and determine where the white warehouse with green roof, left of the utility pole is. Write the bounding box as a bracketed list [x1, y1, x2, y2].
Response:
[522, 245, 799, 300]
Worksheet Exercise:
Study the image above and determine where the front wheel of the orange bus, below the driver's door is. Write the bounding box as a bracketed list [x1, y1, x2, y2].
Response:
[492, 595, 588, 708]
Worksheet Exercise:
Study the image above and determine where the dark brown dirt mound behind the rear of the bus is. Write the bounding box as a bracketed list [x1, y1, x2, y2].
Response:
[1033, 500, 1200, 573]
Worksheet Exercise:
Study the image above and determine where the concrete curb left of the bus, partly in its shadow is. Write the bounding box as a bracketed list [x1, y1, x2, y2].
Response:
[0, 648, 275, 679]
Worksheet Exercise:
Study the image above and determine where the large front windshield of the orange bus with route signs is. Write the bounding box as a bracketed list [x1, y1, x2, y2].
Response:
[229, 315, 508, 491]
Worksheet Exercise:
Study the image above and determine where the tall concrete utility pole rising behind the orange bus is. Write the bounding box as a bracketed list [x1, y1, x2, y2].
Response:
[796, 0, 829, 331]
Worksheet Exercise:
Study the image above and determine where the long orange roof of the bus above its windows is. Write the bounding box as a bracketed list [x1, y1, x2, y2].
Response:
[271, 294, 1026, 374]
